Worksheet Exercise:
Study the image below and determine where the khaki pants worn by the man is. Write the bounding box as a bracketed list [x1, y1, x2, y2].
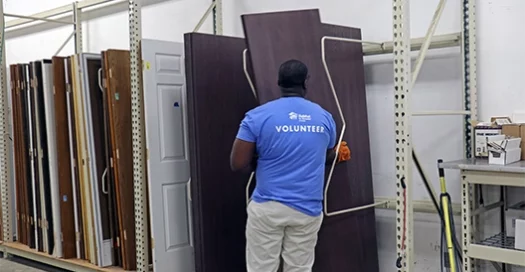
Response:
[246, 201, 323, 272]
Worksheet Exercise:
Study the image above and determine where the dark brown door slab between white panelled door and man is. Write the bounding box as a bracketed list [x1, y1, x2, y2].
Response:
[184, 33, 257, 272]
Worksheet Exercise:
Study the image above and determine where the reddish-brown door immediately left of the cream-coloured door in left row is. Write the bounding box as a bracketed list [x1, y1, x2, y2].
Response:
[52, 57, 77, 259]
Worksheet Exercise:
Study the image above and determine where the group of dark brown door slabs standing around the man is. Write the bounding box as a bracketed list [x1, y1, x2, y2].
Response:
[185, 7, 379, 272]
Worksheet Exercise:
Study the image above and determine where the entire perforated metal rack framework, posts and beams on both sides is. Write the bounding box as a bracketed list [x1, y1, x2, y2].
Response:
[0, 0, 477, 272]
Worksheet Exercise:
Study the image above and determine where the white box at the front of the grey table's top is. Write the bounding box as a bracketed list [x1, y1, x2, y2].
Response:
[487, 135, 521, 165]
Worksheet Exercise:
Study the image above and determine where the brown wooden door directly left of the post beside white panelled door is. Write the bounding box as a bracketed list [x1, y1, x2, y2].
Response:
[103, 50, 137, 270]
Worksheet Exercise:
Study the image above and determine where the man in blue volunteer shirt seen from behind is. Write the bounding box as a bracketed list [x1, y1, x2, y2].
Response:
[231, 60, 349, 272]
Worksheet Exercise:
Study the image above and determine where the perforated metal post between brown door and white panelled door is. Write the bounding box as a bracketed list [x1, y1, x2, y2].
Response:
[128, 0, 149, 272]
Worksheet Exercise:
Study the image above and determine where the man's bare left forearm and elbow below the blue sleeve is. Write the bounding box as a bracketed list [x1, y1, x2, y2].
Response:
[230, 138, 257, 172]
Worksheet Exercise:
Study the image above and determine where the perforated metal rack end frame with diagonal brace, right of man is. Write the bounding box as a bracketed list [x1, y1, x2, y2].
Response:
[393, 0, 477, 272]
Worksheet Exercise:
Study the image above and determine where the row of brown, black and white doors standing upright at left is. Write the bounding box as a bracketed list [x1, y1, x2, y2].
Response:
[10, 50, 145, 270]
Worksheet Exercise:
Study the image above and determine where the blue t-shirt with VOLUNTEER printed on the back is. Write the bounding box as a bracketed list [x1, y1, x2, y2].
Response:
[237, 97, 336, 216]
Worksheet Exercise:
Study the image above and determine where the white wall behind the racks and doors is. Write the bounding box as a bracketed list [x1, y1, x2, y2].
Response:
[4, 0, 525, 272]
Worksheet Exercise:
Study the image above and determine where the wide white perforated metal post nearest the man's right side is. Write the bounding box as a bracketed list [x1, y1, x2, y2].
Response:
[392, 0, 415, 272]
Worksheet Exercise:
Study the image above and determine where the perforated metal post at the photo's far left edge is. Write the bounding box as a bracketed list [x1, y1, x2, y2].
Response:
[0, 0, 13, 242]
